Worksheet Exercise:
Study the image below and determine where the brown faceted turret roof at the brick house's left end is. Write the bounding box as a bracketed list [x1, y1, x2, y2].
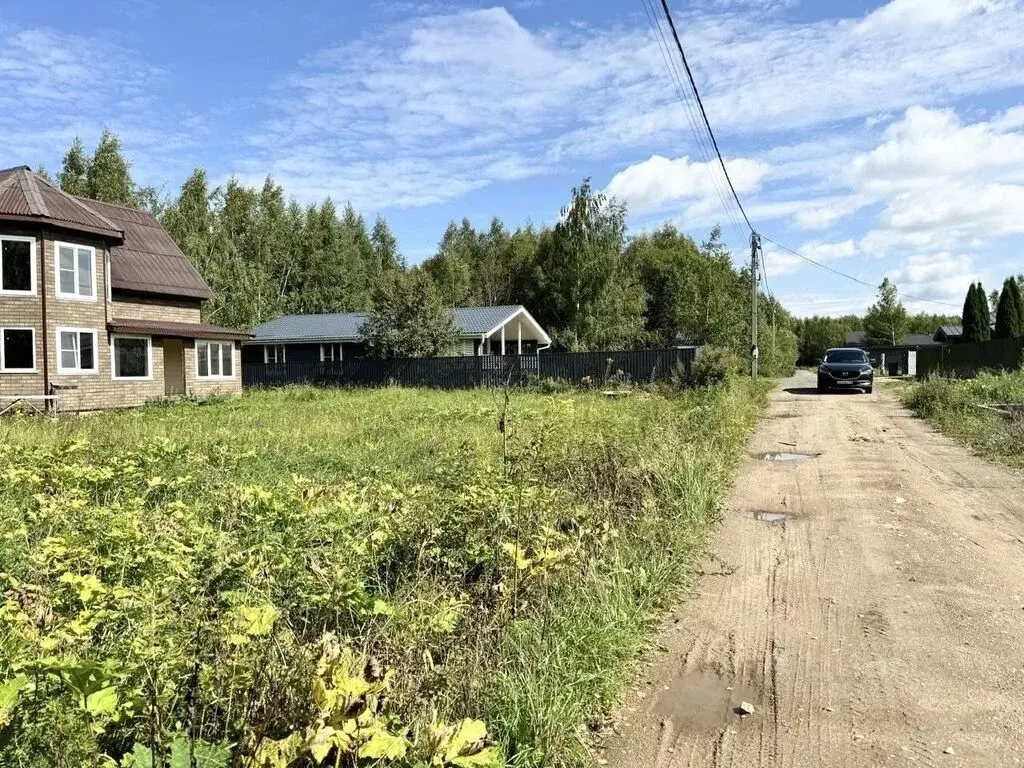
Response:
[0, 166, 124, 243]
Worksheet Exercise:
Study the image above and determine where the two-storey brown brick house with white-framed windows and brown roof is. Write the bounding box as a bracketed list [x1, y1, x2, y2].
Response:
[0, 166, 249, 411]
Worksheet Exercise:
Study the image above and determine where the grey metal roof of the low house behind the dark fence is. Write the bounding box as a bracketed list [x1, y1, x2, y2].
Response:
[253, 304, 543, 342]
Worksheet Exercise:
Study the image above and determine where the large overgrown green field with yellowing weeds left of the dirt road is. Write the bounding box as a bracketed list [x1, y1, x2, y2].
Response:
[0, 382, 765, 768]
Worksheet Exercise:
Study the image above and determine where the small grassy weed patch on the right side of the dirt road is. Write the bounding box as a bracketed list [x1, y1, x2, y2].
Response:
[901, 372, 1024, 467]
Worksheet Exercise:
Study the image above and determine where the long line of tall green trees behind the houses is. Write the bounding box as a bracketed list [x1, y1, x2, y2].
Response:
[44, 131, 799, 374]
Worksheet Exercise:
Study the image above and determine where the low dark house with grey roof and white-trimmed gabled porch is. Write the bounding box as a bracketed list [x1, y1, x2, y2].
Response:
[242, 304, 551, 366]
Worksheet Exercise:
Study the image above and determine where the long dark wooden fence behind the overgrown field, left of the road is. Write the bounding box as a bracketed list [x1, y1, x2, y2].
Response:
[242, 347, 696, 389]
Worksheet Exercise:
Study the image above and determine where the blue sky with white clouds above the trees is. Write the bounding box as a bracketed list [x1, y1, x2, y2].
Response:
[0, 0, 1024, 315]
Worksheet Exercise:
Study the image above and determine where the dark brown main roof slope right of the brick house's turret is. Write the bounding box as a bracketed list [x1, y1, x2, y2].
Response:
[89, 200, 213, 299]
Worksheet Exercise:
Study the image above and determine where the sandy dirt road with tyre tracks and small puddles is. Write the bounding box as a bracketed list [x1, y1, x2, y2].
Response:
[602, 373, 1024, 768]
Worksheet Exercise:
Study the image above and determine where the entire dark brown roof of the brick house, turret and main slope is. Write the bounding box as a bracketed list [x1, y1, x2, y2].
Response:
[0, 166, 213, 299]
